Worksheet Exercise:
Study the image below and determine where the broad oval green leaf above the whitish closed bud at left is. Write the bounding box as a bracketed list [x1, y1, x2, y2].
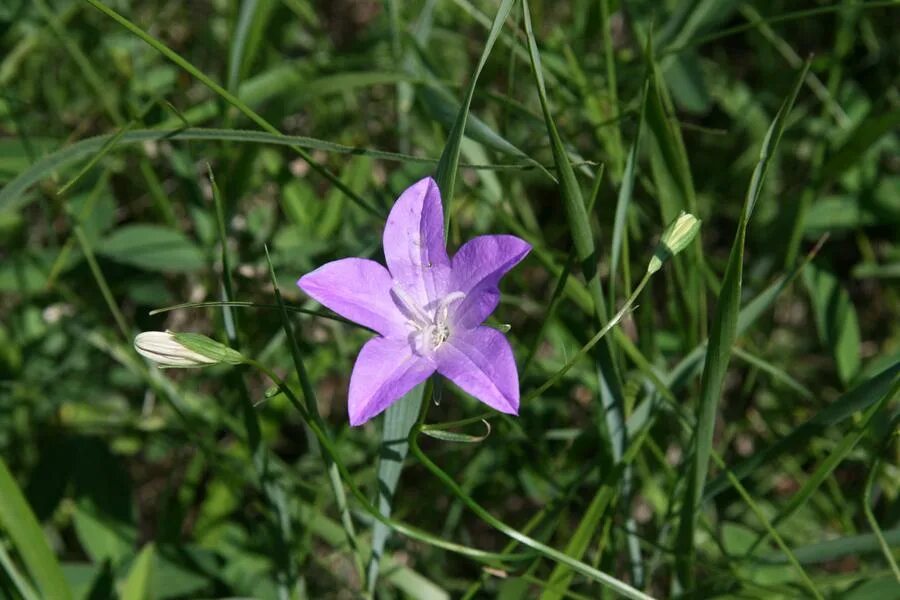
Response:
[97, 224, 205, 273]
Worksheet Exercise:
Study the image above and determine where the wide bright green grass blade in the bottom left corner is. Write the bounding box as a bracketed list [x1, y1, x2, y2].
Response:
[0, 458, 72, 600]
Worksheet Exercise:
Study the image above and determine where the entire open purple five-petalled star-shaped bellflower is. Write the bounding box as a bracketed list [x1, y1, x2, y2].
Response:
[297, 177, 531, 426]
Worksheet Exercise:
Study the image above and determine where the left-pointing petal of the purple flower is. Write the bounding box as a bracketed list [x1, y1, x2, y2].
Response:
[297, 258, 406, 337]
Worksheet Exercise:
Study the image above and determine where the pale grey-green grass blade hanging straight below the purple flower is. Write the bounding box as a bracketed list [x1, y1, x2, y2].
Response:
[366, 384, 424, 594]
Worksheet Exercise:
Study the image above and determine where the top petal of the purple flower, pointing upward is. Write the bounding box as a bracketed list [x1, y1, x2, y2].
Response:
[384, 177, 450, 307]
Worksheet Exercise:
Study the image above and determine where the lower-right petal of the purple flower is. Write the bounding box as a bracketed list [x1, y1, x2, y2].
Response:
[437, 327, 519, 415]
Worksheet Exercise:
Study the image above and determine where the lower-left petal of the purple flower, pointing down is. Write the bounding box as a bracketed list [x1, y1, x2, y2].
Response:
[348, 337, 434, 427]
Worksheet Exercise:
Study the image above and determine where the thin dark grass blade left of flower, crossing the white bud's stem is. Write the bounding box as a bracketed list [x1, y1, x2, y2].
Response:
[265, 247, 365, 580]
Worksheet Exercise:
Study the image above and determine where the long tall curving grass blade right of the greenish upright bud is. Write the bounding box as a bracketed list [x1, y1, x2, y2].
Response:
[676, 62, 809, 590]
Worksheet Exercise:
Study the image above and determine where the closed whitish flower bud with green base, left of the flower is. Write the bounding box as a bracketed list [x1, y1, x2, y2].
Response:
[134, 331, 244, 369]
